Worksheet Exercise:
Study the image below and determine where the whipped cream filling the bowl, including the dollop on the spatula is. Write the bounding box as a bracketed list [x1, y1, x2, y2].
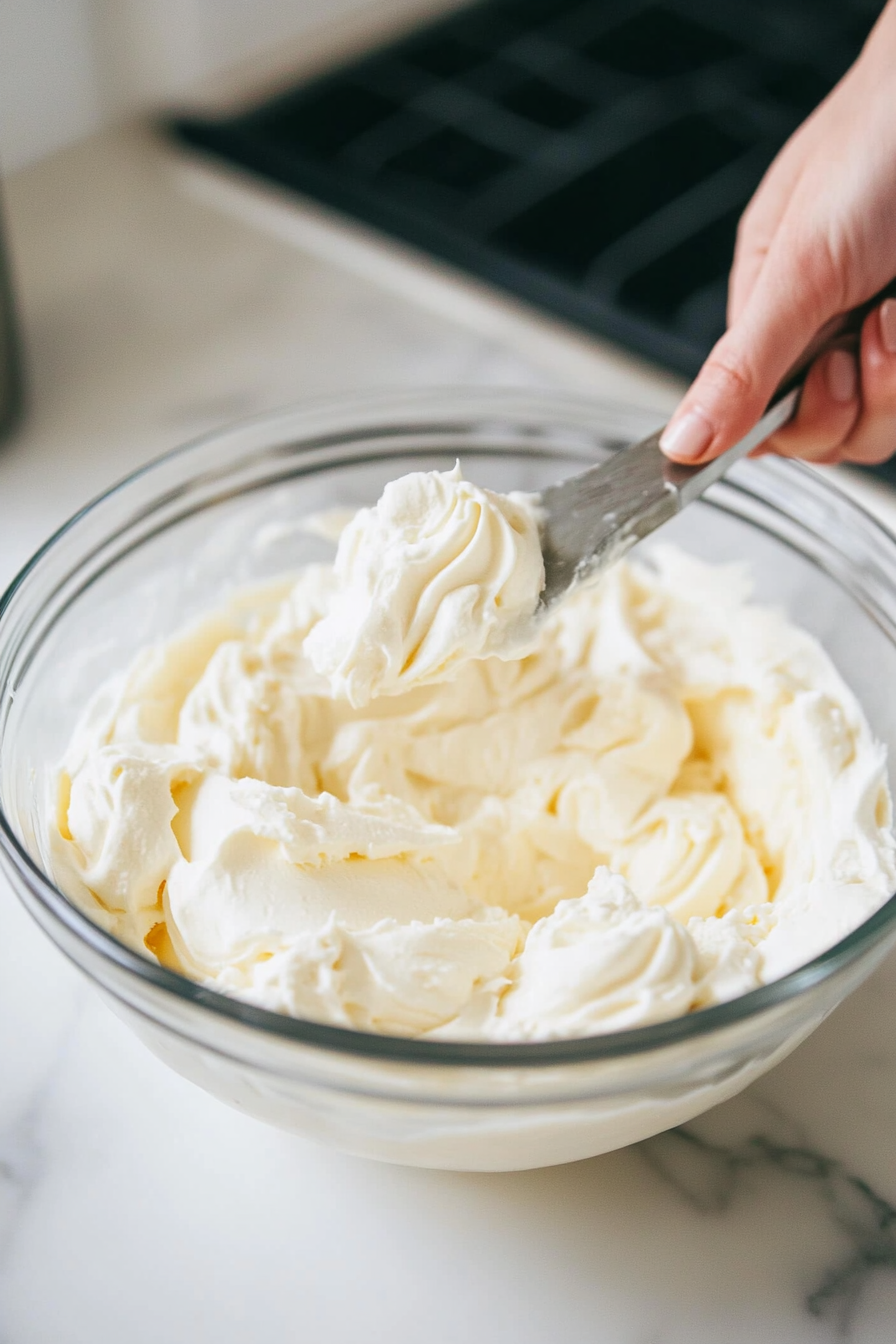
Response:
[48, 469, 896, 1040]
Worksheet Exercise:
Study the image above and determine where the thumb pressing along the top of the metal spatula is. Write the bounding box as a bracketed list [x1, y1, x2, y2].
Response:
[660, 247, 840, 462]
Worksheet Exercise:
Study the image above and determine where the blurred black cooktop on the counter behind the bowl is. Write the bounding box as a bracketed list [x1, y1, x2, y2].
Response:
[172, 0, 883, 375]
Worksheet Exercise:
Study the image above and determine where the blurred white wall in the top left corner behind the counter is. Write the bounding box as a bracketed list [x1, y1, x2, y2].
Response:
[0, 0, 458, 172]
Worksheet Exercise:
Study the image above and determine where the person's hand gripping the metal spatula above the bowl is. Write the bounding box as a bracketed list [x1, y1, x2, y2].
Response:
[661, 0, 896, 464]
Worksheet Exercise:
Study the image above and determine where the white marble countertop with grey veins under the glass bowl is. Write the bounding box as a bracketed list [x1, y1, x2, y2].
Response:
[0, 120, 896, 1344]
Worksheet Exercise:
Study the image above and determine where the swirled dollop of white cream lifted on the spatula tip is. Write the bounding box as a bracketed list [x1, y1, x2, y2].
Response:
[305, 464, 544, 707]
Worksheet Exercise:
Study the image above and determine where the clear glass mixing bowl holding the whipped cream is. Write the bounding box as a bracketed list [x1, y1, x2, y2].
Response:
[0, 391, 896, 1171]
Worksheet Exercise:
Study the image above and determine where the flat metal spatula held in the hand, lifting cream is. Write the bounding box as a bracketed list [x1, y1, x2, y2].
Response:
[541, 281, 896, 606]
